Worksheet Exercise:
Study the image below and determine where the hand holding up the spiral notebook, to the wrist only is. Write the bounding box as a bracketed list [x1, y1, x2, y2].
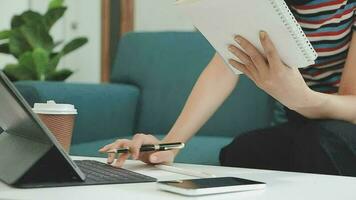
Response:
[229, 31, 312, 110]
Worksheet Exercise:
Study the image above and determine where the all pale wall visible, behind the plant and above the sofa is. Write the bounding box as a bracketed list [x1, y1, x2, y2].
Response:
[0, 0, 194, 83]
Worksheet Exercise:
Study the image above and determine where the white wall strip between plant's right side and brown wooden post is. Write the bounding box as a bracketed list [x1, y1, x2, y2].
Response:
[57, 0, 101, 83]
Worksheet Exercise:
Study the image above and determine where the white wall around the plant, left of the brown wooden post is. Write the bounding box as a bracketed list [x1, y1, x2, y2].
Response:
[0, 0, 101, 83]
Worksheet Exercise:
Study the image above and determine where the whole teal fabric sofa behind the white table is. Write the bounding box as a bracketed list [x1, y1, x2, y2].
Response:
[16, 32, 274, 165]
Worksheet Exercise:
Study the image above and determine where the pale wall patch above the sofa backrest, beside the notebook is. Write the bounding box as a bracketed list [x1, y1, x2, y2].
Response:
[134, 0, 194, 31]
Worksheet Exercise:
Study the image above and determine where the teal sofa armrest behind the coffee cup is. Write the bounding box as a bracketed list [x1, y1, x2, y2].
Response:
[15, 81, 139, 144]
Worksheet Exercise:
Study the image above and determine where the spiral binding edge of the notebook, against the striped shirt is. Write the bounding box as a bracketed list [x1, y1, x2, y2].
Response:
[269, 0, 318, 61]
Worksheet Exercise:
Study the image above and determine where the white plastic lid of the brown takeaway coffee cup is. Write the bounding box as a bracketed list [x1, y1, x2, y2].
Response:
[32, 100, 78, 115]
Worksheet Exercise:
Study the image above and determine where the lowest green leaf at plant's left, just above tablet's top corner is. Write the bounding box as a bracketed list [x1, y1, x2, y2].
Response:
[3, 64, 35, 81]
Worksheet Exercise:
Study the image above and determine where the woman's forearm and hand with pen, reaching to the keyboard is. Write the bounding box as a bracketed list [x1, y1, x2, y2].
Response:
[100, 54, 238, 167]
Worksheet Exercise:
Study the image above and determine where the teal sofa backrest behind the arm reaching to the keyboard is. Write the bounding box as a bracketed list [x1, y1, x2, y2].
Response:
[111, 32, 273, 137]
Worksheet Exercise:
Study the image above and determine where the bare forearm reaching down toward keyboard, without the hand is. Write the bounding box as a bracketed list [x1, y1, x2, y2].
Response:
[164, 54, 238, 142]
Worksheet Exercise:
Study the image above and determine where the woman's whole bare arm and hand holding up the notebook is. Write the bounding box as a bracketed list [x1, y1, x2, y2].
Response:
[230, 32, 356, 123]
